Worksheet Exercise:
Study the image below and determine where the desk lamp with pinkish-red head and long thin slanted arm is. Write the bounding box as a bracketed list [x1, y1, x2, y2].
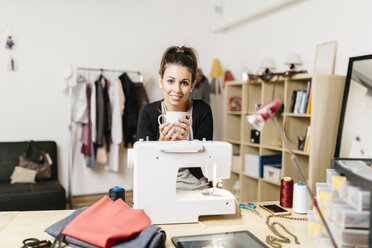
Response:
[247, 99, 337, 248]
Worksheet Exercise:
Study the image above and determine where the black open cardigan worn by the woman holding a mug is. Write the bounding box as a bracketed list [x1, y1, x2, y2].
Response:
[137, 100, 213, 178]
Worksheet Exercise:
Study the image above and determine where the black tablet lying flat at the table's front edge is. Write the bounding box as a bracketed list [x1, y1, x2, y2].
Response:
[172, 231, 268, 248]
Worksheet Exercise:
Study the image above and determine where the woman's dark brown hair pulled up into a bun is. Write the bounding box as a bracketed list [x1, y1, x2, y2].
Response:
[159, 46, 198, 83]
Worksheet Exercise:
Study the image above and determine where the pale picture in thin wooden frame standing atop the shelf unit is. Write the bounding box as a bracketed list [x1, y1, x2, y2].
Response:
[313, 41, 337, 75]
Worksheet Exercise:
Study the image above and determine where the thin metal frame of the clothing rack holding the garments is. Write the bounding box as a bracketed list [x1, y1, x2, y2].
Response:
[68, 67, 143, 209]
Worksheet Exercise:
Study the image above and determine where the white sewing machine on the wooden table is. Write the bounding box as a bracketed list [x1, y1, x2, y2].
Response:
[128, 140, 235, 224]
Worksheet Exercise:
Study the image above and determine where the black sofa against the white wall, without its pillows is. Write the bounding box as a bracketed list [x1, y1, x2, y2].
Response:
[0, 141, 66, 211]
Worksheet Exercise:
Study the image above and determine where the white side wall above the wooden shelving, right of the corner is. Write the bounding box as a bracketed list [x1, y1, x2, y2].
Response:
[217, 0, 372, 75]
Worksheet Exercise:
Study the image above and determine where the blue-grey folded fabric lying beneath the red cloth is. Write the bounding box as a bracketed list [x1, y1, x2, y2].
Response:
[45, 208, 166, 248]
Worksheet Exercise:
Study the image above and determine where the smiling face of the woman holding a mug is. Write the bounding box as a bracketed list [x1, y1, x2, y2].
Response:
[159, 64, 195, 111]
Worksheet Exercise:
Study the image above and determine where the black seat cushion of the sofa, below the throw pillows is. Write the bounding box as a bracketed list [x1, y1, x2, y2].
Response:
[0, 180, 66, 211]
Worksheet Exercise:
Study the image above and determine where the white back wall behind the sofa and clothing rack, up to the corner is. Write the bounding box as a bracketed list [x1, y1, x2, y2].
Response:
[0, 0, 222, 195]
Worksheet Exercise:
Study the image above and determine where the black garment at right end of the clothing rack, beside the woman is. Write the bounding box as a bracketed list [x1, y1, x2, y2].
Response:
[119, 73, 149, 147]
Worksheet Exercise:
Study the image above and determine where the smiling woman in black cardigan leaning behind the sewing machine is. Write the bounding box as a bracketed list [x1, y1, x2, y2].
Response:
[137, 46, 213, 178]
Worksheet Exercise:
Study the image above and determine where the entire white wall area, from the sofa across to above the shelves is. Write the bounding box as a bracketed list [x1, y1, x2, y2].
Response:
[0, 0, 372, 195]
